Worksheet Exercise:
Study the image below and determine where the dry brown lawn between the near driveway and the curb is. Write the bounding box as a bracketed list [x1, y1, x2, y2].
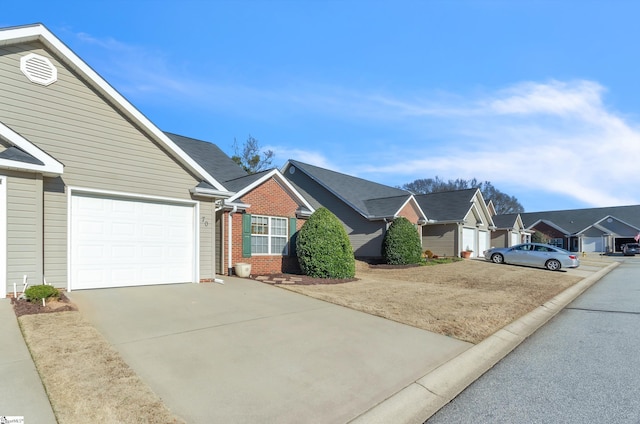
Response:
[282, 260, 607, 343]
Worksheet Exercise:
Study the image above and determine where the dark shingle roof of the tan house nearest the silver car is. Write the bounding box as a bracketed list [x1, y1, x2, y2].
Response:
[415, 188, 478, 222]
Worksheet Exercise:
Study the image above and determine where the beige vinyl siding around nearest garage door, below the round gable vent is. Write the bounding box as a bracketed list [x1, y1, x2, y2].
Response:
[0, 43, 211, 287]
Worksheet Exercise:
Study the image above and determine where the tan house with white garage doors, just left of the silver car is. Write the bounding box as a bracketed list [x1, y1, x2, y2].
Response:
[415, 188, 495, 257]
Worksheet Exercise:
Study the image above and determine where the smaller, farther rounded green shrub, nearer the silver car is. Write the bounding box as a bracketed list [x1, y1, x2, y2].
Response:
[382, 217, 424, 265]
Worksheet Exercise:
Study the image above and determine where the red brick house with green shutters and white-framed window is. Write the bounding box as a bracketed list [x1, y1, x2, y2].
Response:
[167, 133, 314, 275]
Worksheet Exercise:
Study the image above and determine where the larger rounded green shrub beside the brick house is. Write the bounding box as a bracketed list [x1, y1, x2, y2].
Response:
[296, 208, 356, 278]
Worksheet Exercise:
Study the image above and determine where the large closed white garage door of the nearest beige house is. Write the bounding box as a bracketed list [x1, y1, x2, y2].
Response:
[70, 194, 196, 290]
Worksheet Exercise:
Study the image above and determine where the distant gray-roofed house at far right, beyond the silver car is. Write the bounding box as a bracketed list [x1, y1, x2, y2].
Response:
[520, 205, 640, 252]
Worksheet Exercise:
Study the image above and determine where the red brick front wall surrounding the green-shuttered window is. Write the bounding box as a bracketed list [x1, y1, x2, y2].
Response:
[224, 178, 305, 275]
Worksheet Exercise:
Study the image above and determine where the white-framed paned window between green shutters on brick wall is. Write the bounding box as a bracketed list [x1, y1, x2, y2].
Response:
[251, 215, 288, 255]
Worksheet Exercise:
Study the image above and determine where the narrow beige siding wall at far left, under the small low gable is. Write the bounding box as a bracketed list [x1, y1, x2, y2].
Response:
[2, 171, 43, 286]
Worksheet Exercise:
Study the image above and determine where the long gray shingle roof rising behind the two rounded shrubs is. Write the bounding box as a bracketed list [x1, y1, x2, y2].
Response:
[289, 160, 411, 219]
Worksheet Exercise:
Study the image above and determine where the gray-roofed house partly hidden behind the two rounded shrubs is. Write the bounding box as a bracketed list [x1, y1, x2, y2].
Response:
[282, 160, 426, 259]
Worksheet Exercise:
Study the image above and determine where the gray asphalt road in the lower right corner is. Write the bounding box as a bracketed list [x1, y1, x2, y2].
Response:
[427, 257, 640, 424]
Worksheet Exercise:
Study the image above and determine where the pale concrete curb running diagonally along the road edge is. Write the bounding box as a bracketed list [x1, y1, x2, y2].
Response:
[350, 262, 620, 424]
